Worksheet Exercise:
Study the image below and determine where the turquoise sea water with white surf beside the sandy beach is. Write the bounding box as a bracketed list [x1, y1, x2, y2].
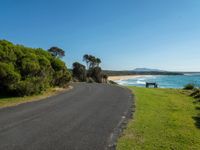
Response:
[116, 74, 200, 88]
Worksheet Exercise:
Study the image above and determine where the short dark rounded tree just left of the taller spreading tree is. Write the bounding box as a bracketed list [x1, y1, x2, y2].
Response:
[72, 62, 86, 81]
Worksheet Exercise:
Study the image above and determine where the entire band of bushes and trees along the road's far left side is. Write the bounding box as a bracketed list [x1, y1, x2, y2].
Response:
[0, 40, 108, 99]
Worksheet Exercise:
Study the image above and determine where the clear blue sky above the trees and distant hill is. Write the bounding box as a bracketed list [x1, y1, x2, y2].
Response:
[0, 0, 200, 71]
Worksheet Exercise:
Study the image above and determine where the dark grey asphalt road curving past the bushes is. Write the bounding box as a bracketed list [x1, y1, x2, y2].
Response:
[0, 83, 132, 150]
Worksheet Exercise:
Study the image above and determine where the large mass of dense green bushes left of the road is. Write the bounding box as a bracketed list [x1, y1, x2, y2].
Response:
[0, 40, 71, 96]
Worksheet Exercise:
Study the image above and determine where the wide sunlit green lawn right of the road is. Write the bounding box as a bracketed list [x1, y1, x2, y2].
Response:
[117, 87, 200, 150]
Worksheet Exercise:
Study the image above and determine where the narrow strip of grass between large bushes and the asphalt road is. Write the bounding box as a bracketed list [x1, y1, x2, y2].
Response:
[0, 88, 68, 108]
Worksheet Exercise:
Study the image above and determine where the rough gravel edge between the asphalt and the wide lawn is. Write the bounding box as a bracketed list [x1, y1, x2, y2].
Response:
[105, 85, 135, 150]
